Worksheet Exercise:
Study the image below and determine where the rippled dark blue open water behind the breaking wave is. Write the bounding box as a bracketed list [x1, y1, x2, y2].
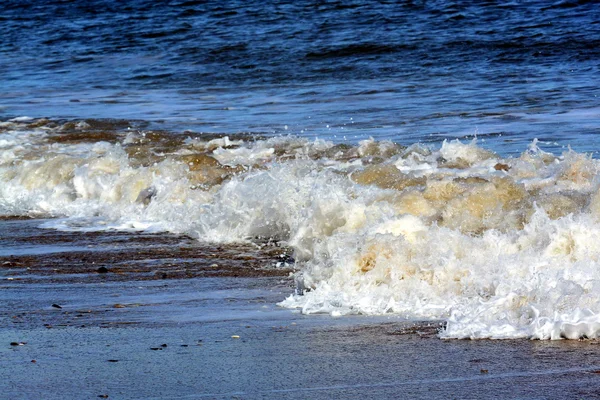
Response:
[0, 0, 600, 154]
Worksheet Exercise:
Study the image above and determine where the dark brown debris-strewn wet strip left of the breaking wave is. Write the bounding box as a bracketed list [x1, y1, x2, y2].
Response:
[0, 219, 292, 283]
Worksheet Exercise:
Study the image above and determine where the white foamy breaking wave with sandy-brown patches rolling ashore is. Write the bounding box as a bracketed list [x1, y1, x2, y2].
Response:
[0, 121, 600, 339]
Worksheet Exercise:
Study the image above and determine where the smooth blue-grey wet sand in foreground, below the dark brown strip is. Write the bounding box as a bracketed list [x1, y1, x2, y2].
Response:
[0, 284, 600, 399]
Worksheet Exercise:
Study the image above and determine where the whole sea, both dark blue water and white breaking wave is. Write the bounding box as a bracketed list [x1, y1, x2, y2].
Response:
[0, 0, 600, 339]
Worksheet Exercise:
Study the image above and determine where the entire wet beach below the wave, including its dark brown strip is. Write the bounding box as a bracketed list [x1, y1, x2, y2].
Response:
[0, 219, 600, 399]
